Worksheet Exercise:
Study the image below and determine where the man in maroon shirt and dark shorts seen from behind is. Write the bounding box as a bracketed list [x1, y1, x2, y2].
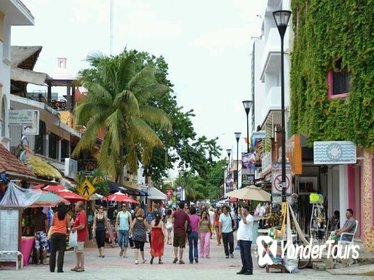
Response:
[173, 202, 189, 264]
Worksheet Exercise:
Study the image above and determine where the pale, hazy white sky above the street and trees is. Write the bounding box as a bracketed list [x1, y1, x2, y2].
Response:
[11, 0, 267, 161]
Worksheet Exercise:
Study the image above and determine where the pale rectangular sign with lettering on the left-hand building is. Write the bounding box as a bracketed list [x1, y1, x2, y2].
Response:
[9, 110, 39, 135]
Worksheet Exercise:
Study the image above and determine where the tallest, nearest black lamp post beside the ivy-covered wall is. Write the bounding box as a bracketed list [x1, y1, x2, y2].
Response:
[273, 10, 291, 202]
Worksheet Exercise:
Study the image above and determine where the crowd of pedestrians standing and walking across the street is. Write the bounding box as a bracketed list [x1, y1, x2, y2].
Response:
[49, 202, 253, 275]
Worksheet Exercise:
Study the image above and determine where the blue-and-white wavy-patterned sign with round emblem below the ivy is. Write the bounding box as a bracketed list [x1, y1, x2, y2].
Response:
[313, 141, 356, 164]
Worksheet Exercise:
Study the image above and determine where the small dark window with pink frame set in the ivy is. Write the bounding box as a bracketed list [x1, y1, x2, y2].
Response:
[327, 69, 352, 99]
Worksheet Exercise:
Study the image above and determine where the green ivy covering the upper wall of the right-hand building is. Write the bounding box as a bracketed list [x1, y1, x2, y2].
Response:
[291, 0, 374, 149]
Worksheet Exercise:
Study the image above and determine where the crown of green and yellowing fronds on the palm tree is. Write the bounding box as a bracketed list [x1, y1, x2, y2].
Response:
[74, 50, 171, 183]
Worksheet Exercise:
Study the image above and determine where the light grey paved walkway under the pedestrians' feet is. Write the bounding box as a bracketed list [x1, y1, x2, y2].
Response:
[0, 240, 373, 280]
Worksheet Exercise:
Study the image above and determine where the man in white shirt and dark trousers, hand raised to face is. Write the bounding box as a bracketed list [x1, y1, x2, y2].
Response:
[236, 206, 253, 275]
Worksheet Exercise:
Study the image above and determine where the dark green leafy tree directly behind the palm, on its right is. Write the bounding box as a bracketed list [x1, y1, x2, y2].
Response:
[127, 52, 221, 184]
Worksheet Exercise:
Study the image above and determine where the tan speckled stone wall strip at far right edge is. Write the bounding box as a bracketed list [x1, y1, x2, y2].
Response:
[359, 151, 374, 252]
